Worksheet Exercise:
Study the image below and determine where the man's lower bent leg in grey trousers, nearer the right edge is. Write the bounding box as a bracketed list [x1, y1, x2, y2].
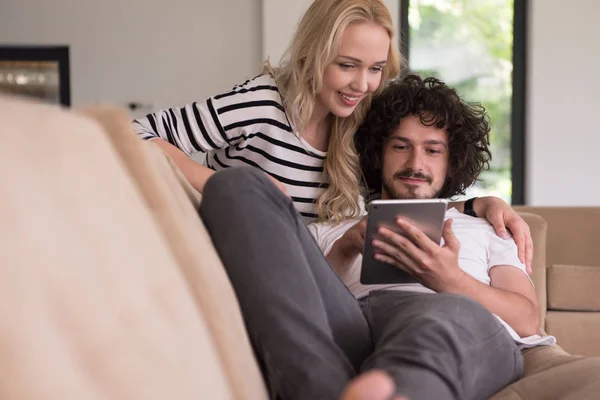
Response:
[363, 291, 523, 400]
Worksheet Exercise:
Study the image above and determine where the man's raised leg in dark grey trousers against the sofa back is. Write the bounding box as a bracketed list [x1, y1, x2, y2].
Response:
[200, 168, 372, 399]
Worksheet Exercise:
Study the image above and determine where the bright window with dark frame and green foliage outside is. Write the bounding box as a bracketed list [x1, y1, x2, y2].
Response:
[400, 0, 527, 204]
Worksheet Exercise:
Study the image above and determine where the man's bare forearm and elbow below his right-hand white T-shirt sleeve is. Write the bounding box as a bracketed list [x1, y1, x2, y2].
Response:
[445, 265, 540, 337]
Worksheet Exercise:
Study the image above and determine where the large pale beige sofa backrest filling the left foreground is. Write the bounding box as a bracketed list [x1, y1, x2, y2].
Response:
[0, 96, 234, 400]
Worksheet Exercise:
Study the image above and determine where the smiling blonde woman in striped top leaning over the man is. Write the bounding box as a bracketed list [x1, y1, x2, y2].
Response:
[133, 0, 533, 266]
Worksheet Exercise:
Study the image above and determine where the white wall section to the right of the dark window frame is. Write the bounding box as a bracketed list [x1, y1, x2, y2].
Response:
[526, 0, 600, 206]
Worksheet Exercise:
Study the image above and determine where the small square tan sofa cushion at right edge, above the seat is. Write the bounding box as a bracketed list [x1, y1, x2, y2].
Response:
[547, 264, 600, 311]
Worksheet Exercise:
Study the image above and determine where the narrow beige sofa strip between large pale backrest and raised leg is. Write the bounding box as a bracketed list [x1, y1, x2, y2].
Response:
[81, 106, 267, 400]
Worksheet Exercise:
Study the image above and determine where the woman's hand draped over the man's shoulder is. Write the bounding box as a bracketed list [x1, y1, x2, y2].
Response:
[473, 196, 533, 275]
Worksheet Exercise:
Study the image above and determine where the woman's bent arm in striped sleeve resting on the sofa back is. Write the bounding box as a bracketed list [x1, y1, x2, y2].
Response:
[133, 75, 287, 194]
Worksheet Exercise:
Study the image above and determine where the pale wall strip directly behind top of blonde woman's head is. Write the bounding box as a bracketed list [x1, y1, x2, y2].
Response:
[261, 0, 400, 65]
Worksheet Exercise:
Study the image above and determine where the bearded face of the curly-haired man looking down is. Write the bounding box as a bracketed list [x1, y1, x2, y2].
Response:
[381, 115, 449, 199]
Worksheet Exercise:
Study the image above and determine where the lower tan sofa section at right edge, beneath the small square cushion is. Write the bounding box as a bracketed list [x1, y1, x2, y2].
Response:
[546, 311, 600, 357]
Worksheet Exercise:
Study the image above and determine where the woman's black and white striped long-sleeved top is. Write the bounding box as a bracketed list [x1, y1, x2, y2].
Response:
[133, 75, 327, 223]
